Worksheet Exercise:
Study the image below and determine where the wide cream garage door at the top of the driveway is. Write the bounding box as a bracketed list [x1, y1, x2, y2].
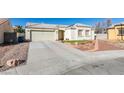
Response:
[31, 31, 55, 41]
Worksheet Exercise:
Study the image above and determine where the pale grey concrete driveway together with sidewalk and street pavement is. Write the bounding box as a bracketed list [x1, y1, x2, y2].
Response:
[0, 41, 124, 75]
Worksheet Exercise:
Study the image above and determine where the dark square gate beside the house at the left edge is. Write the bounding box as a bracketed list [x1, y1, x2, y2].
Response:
[4, 32, 17, 44]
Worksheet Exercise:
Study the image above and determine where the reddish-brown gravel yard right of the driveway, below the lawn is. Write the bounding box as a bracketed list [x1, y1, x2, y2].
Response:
[68, 40, 124, 51]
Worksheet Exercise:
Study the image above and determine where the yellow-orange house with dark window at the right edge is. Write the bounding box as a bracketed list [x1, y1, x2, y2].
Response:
[107, 23, 124, 40]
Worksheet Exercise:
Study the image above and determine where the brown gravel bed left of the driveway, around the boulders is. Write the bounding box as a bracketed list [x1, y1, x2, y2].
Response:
[0, 43, 29, 71]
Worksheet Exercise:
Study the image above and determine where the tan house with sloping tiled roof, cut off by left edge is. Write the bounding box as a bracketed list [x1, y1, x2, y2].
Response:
[0, 18, 12, 43]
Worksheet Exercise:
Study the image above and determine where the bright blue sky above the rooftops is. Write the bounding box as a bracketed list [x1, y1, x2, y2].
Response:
[10, 18, 124, 26]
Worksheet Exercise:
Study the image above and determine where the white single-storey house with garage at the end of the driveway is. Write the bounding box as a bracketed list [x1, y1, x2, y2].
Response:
[25, 23, 94, 41]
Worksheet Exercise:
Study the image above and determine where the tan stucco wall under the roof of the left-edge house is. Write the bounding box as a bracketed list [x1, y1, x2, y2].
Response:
[0, 21, 12, 43]
